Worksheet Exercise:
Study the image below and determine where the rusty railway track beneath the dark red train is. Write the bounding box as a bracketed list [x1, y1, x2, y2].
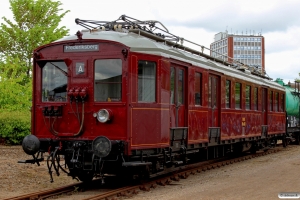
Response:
[6, 147, 283, 200]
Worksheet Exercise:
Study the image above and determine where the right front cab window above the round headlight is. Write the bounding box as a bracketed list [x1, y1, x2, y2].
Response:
[94, 59, 122, 102]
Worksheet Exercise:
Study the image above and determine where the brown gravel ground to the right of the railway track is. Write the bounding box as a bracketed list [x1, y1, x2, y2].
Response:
[131, 146, 300, 200]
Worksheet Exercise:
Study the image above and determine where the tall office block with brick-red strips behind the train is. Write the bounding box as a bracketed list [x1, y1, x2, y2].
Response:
[210, 31, 265, 74]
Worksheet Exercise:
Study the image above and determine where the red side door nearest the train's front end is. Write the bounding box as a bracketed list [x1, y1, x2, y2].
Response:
[170, 65, 187, 127]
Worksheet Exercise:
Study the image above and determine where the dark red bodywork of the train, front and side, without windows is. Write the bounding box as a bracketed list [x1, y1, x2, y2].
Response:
[32, 40, 285, 154]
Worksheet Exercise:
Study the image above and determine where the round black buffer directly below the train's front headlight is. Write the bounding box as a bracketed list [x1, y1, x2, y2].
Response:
[92, 136, 111, 158]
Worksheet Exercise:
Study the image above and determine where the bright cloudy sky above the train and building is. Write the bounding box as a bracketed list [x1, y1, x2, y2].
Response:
[0, 0, 300, 83]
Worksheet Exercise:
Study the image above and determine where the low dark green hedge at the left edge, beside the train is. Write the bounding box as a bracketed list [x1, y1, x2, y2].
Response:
[0, 110, 31, 144]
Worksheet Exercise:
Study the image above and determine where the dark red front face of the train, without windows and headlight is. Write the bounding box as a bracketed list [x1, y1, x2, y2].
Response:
[32, 41, 128, 140]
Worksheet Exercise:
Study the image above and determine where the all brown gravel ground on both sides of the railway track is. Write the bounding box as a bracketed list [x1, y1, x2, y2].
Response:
[0, 146, 300, 200]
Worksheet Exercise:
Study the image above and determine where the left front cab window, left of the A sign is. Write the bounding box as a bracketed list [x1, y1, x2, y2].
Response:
[42, 61, 68, 102]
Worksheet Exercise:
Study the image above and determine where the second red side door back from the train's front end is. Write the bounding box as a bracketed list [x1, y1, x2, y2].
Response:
[208, 75, 220, 127]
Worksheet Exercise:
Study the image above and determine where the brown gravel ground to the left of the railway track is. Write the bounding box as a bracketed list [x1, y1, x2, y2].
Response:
[0, 145, 77, 199]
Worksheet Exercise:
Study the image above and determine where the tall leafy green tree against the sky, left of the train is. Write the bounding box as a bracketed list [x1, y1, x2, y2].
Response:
[0, 0, 69, 77]
